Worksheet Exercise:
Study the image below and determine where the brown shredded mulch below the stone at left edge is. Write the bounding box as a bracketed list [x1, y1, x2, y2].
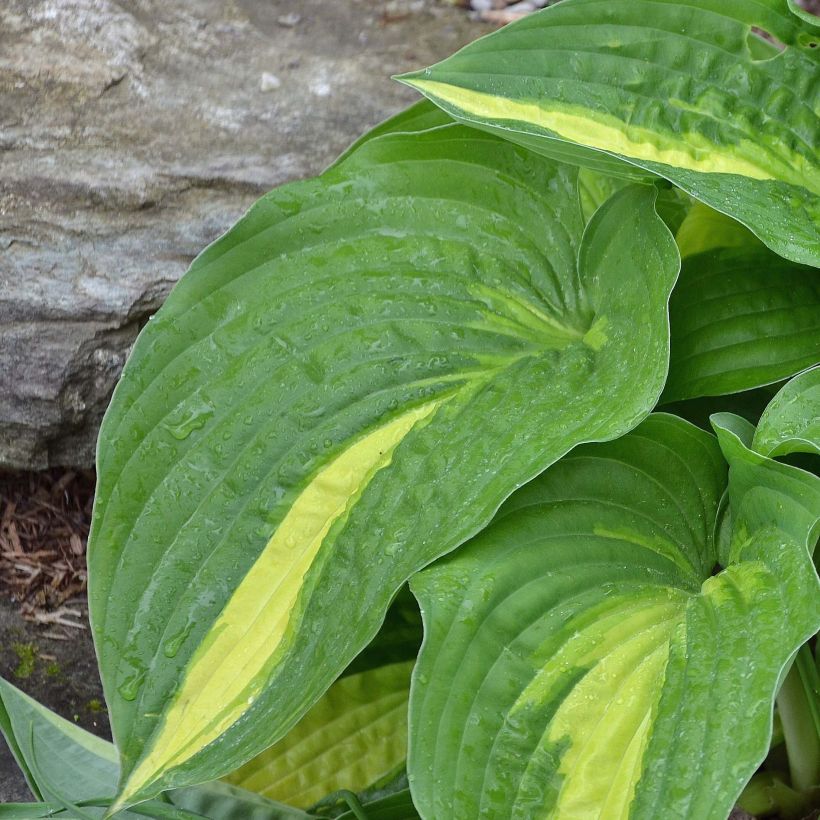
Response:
[0, 469, 94, 637]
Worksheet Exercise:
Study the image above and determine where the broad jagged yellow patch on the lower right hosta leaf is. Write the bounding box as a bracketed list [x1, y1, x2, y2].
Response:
[513, 589, 688, 820]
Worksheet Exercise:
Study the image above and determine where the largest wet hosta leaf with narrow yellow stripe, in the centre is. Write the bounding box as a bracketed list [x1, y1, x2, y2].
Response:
[89, 124, 679, 802]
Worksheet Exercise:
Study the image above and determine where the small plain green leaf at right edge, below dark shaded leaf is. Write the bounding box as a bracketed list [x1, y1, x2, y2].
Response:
[752, 367, 820, 458]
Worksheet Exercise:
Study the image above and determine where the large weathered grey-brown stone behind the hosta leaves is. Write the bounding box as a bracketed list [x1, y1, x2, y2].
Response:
[0, 0, 486, 468]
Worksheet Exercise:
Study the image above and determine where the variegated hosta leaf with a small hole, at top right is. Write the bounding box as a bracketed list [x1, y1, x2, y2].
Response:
[400, 0, 820, 265]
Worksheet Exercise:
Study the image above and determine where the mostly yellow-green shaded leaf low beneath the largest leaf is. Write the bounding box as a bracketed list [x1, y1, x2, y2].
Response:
[226, 661, 413, 808]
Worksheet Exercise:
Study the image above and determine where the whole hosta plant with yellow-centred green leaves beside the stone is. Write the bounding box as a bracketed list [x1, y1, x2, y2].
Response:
[0, 0, 820, 820]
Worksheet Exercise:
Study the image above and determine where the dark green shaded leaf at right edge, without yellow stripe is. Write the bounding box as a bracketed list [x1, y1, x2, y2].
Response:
[662, 247, 820, 402]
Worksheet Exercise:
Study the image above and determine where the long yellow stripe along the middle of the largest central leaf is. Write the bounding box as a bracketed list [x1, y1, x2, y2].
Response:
[114, 398, 446, 808]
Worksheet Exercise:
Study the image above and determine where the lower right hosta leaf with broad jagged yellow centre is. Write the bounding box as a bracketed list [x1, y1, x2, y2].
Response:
[409, 414, 820, 820]
